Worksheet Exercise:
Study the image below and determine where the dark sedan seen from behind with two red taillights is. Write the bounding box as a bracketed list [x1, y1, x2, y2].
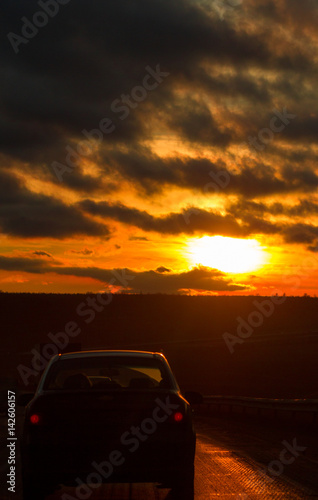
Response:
[21, 350, 196, 500]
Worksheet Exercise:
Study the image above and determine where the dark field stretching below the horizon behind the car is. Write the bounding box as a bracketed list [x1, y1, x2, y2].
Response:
[0, 293, 318, 398]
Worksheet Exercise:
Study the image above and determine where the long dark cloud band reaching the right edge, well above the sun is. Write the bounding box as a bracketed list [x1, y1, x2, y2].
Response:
[103, 148, 317, 198]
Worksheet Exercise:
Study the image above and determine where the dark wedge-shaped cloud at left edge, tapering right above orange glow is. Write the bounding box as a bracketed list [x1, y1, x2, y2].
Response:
[0, 171, 110, 238]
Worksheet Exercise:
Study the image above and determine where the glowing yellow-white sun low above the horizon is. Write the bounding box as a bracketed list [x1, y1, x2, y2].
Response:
[188, 236, 265, 273]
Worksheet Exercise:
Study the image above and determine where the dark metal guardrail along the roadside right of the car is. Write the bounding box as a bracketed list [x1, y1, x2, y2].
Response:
[195, 396, 318, 423]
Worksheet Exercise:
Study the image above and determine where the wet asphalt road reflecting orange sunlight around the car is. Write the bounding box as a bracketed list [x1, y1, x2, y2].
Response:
[0, 417, 318, 500]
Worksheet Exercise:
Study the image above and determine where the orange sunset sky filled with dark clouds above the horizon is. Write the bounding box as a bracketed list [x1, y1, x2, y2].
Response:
[0, 0, 318, 296]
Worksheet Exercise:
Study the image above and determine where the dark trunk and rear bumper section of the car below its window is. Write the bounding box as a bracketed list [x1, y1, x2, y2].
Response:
[29, 390, 187, 471]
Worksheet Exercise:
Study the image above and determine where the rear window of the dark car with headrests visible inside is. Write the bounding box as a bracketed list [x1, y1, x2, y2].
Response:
[43, 356, 173, 391]
